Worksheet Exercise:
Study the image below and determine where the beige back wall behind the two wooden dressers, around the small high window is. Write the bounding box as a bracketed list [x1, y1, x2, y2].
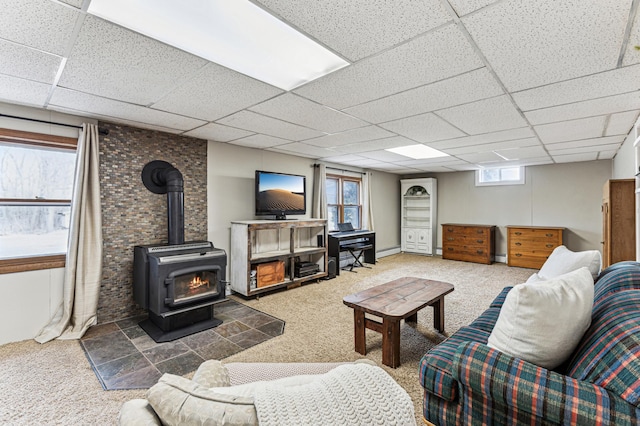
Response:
[436, 160, 611, 256]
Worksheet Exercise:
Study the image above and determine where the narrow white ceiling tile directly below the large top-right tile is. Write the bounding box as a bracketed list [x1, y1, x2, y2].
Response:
[513, 65, 640, 111]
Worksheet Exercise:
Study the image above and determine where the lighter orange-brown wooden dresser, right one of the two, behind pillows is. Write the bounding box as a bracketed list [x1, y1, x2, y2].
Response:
[507, 226, 564, 269]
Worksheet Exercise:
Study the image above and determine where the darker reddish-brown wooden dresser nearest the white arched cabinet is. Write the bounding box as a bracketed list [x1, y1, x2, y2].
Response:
[442, 223, 496, 264]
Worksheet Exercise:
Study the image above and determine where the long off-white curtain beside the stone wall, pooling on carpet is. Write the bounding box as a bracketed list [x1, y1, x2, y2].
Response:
[36, 124, 102, 343]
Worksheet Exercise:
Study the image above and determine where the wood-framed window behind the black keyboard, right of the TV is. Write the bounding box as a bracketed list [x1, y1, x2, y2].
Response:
[326, 175, 362, 231]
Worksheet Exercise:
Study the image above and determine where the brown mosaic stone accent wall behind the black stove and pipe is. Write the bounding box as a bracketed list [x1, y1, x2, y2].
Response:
[98, 122, 207, 323]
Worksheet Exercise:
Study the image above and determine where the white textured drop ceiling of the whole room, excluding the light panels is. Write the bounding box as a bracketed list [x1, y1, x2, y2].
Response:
[0, 0, 640, 175]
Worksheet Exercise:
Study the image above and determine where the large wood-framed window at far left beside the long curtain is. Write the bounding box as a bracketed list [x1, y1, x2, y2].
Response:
[0, 129, 77, 273]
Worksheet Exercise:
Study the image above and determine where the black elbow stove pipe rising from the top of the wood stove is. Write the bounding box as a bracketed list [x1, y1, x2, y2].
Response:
[142, 160, 184, 245]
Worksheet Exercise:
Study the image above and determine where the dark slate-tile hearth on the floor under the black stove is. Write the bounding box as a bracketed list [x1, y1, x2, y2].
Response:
[80, 300, 284, 390]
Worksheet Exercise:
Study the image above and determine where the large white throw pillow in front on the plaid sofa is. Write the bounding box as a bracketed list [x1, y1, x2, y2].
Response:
[487, 267, 594, 369]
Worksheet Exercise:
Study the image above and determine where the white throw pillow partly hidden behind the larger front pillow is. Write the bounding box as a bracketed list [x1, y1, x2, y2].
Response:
[538, 246, 602, 280]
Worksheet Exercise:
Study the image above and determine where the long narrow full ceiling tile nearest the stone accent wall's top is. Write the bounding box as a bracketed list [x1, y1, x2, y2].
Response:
[49, 88, 205, 130]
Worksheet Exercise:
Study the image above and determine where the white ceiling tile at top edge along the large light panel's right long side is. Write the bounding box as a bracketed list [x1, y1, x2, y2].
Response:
[258, 0, 451, 61]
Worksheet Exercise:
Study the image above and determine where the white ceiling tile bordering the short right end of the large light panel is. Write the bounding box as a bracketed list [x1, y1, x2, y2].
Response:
[294, 25, 483, 110]
